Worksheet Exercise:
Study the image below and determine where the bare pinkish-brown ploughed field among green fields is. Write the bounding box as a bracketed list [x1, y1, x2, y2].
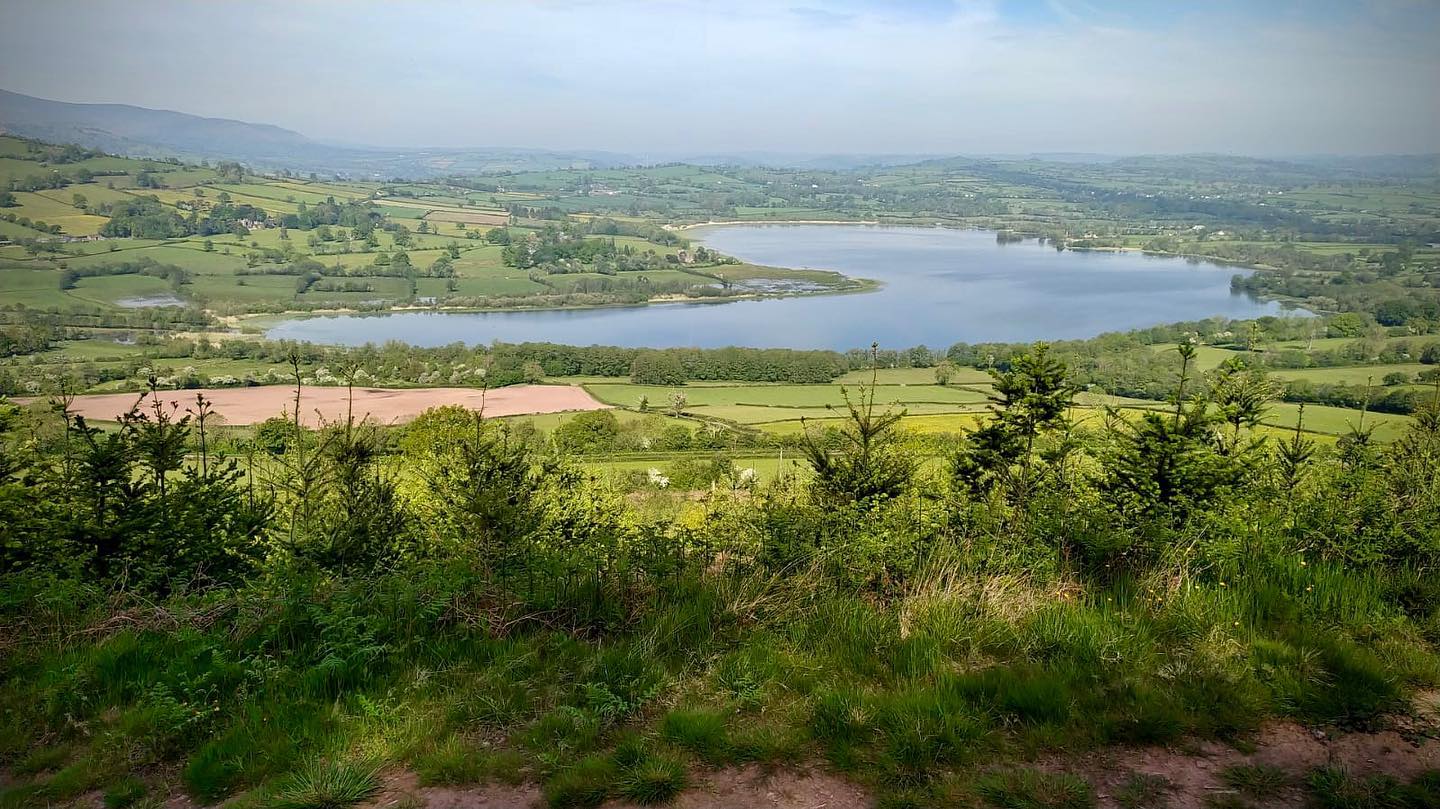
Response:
[53, 384, 608, 426]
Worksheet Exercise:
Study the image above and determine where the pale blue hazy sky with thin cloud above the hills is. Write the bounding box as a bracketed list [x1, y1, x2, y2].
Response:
[0, 0, 1440, 155]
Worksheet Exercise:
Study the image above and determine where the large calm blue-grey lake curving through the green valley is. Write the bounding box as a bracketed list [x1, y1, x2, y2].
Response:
[266, 225, 1300, 350]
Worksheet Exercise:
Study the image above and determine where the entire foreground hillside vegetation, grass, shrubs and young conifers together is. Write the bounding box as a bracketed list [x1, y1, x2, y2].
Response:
[0, 343, 1440, 808]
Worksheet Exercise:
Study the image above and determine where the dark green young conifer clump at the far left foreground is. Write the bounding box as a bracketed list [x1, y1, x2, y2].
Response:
[0, 397, 272, 592]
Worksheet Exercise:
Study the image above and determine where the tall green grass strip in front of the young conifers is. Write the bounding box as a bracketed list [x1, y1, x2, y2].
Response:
[0, 544, 1436, 806]
